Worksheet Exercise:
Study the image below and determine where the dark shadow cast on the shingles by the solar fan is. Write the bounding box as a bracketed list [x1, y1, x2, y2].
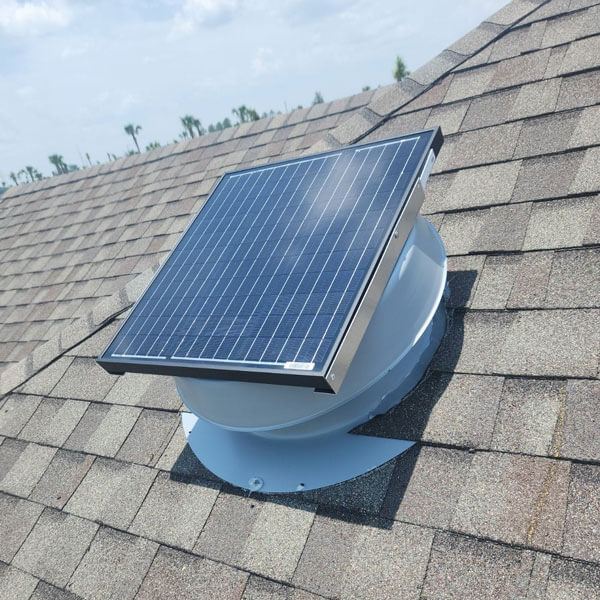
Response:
[166, 270, 477, 529]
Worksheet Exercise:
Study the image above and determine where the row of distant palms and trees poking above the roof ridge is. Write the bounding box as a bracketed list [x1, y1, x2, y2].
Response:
[0, 56, 409, 193]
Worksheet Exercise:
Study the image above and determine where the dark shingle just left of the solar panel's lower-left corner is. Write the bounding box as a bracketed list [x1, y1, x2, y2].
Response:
[52, 358, 117, 400]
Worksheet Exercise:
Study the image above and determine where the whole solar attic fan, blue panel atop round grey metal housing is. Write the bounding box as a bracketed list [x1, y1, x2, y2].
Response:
[98, 128, 446, 492]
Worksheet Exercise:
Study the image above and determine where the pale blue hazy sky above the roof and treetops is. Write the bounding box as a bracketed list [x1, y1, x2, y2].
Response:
[0, 0, 506, 184]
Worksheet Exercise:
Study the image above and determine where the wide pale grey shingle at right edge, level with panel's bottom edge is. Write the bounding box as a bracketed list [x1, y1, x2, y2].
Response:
[496, 310, 600, 377]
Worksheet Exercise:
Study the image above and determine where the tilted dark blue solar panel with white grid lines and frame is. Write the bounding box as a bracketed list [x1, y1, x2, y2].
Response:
[99, 129, 442, 391]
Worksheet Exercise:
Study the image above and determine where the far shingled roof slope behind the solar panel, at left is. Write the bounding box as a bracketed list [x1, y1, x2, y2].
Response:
[0, 92, 373, 370]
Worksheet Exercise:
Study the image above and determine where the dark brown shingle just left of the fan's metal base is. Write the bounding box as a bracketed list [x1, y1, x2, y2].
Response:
[117, 409, 179, 466]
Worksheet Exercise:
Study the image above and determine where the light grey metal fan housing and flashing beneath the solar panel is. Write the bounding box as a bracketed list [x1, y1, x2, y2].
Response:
[175, 217, 447, 492]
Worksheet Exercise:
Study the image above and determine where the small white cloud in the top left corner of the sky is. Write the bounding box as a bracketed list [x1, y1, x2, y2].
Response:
[0, 0, 73, 35]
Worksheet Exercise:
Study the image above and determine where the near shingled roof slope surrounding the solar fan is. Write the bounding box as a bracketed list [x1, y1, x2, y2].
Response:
[0, 0, 600, 600]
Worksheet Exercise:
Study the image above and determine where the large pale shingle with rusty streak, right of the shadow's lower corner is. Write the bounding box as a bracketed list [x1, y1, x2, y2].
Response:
[451, 452, 570, 551]
